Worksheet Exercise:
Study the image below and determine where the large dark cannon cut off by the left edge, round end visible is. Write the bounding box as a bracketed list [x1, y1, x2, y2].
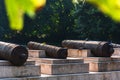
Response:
[0, 41, 28, 66]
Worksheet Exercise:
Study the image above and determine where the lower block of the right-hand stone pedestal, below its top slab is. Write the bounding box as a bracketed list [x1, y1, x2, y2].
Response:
[89, 61, 120, 72]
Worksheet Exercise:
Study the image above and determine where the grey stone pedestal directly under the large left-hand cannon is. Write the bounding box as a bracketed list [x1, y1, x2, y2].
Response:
[0, 60, 41, 78]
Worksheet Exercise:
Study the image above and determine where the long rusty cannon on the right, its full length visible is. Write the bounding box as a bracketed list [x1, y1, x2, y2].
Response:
[62, 40, 114, 57]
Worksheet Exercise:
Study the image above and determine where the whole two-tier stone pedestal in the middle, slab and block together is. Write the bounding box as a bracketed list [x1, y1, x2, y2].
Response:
[41, 59, 89, 75]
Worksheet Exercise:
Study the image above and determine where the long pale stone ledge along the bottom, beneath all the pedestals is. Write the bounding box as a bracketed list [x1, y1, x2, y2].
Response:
[0, 71, 120, 80]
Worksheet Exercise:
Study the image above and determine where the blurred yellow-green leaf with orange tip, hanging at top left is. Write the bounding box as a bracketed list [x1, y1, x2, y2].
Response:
[5, 0, 46, 31]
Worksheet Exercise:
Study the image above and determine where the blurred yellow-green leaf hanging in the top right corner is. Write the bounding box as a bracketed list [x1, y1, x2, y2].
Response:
[86, 0, 120, 22]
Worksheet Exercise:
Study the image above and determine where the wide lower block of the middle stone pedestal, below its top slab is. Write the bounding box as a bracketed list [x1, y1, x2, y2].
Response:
[41, 63, 89, 75]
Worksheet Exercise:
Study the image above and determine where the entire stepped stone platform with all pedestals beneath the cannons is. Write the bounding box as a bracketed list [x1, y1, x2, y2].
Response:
[0, 49, 120, 80]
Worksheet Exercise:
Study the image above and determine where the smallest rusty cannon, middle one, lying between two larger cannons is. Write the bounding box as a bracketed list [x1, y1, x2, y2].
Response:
[27, 41, 68, 59]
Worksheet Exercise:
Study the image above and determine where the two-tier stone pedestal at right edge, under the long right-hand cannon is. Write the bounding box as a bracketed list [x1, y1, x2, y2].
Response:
[84, 57, 120, 72]
